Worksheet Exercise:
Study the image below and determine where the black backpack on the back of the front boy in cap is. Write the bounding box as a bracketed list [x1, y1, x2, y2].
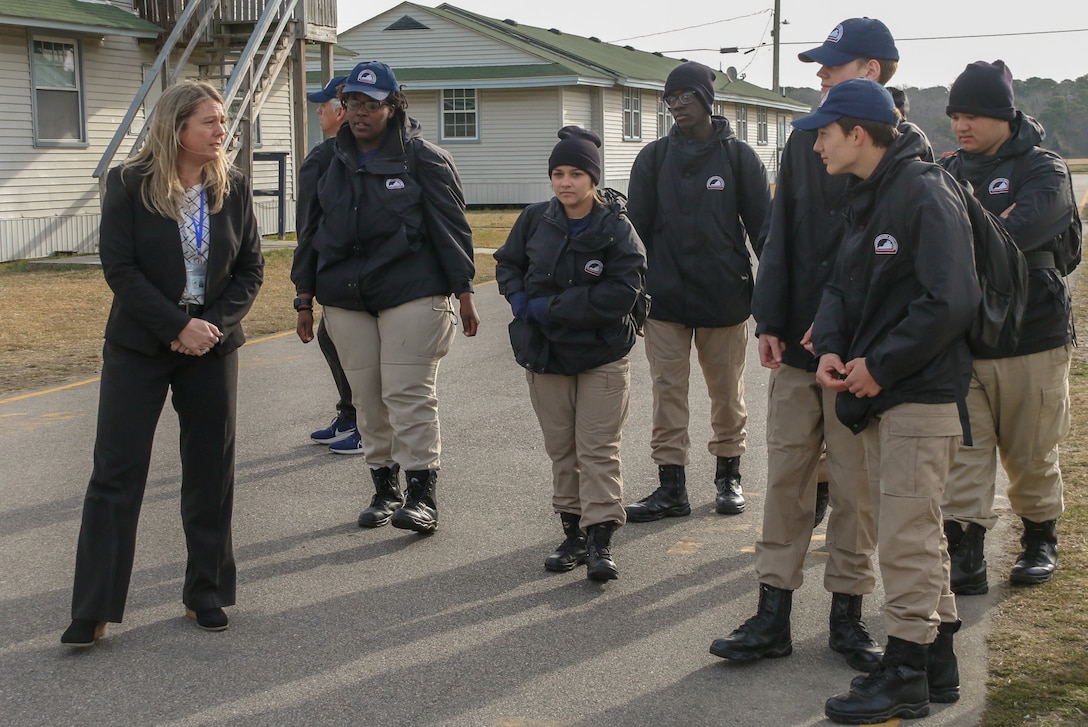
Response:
[961, 176, 1027, 358]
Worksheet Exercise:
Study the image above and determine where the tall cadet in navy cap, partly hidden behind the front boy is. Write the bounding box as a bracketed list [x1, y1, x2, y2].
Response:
[710, 17, 905, 671]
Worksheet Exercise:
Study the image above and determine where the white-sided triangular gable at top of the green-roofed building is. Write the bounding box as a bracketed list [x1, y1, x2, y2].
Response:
[336, 3, 543, 71]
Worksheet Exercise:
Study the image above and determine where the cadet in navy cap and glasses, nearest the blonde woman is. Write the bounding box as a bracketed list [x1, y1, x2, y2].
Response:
[290, 61, 480, 533]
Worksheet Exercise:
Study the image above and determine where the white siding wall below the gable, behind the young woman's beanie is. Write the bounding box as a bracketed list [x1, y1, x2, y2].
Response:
[408, 88, 562, 205]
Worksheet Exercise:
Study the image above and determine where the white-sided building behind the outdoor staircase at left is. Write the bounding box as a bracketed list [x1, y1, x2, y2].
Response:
[0, 0, 335, 261]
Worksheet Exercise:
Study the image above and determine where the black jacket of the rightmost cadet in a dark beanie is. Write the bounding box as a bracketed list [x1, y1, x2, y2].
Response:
[941, 112, 1073, 356]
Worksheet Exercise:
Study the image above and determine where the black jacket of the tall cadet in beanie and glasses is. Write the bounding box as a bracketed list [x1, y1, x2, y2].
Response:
[627, 116, 770, 328]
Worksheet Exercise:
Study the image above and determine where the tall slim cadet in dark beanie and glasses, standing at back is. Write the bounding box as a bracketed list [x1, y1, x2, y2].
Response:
[627, 62, 770, 522]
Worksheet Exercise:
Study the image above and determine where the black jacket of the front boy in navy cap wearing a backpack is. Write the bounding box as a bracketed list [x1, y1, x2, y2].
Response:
[813, 130, 980, 431]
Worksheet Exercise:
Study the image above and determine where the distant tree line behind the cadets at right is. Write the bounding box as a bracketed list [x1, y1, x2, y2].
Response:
[786, 75, 1088, 159]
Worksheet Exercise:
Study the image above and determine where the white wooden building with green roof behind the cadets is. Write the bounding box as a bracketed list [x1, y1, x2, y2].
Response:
[335, 2, 809, 205]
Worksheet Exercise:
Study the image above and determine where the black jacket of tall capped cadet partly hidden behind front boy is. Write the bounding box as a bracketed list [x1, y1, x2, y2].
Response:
[752, 122, 932, 371]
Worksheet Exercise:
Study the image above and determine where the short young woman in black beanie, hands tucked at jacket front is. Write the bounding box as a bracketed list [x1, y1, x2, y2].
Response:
[495, 126, 646, 580]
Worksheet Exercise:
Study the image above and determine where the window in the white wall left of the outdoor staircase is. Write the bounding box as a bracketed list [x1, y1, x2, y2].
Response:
[30, 36, 87, 146]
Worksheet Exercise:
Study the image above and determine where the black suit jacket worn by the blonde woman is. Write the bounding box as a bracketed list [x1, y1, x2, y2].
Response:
[99, 167, 264, 356]
